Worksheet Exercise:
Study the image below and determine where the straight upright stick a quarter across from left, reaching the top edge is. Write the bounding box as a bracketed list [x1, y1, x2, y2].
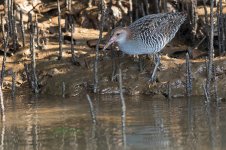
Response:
[57, 0, 63, 60]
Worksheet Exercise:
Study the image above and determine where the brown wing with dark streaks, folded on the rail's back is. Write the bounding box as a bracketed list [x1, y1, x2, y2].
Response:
[129, 12, 186, 40]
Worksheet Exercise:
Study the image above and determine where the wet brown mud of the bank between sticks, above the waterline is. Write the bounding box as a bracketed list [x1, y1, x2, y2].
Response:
[1, 0, 226, 97]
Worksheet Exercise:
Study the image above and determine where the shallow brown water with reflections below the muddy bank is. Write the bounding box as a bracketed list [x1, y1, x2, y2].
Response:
[0, 96, 226, 150]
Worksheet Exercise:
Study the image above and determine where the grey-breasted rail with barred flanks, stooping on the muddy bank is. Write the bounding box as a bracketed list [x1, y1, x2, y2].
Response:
[103, 12, 186, 81]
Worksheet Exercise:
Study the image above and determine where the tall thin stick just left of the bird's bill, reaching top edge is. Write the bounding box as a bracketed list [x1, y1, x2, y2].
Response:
[93, 0, 105, 93]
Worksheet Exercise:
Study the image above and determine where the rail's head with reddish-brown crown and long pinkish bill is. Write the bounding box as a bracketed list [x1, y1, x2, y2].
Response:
[103, 27, 129, 50]
